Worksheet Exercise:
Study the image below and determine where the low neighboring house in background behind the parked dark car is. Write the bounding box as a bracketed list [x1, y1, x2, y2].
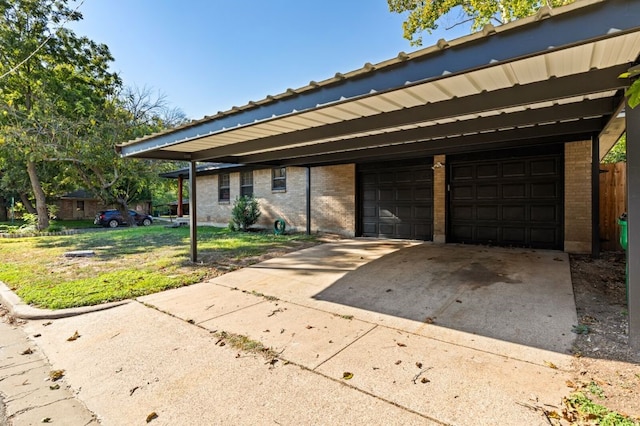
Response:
[55, 189, 151, 220]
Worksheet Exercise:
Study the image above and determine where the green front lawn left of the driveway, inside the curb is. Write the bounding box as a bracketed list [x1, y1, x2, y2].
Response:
[0, 226, 313, 309]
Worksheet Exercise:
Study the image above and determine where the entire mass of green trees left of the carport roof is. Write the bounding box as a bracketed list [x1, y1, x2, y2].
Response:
[0, 0, 186, 229]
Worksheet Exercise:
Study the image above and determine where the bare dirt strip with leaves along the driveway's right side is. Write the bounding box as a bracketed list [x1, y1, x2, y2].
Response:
[571, 252, 640, 418]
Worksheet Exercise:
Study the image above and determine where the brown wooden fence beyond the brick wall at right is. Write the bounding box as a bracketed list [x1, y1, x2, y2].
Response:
[600, 162, 627, 250]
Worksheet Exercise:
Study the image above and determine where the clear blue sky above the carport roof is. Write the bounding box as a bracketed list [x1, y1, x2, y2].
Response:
[71, 0, 469, 118]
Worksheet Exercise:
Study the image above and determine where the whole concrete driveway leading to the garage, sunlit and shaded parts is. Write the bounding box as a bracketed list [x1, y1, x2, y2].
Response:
[2, 240, 577, 425]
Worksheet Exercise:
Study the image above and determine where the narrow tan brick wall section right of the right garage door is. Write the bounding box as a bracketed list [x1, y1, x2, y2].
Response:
[564, 141, 591, 253]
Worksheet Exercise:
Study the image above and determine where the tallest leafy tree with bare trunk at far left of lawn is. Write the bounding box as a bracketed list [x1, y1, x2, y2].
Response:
[0, 0, 120, 229]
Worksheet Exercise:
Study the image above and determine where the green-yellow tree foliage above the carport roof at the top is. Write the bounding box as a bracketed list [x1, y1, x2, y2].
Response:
[387, 0, 574, 46]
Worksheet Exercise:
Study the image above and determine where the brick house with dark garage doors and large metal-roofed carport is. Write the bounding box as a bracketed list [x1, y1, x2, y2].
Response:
[118, 0, 640, 347]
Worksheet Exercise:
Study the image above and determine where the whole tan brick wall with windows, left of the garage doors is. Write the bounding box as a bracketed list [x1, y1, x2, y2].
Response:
[192, 164, 356, 236]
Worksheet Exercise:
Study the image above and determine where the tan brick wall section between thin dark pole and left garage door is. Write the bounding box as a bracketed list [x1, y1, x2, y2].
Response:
[311, 164, 356, 237]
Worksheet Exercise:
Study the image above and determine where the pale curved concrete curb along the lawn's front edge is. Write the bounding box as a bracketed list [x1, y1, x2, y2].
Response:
[0, 281, 131, 320]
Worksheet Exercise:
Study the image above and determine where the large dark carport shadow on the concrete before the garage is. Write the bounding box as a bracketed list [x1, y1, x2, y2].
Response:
[313, 243, 577, 353]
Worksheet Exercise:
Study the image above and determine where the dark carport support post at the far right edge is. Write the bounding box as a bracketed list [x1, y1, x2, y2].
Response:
[625, 90, 640, 352]
